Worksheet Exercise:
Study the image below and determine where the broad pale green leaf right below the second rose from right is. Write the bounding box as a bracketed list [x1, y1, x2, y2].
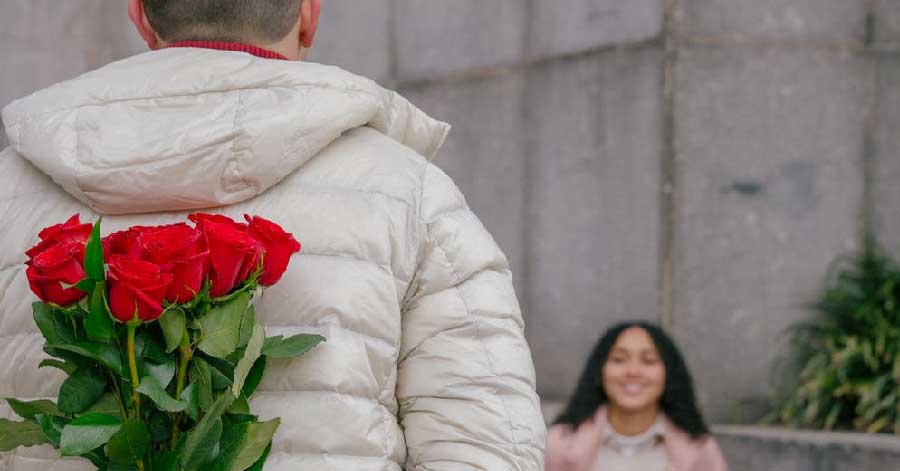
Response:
[197, 292, 250, 358]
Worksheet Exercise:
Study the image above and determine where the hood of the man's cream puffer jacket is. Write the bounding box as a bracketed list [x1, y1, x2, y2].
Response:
[3, 48, 449, 214]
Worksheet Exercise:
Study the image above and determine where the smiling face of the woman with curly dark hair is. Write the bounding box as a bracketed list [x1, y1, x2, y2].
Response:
[602, 327, 666, 412]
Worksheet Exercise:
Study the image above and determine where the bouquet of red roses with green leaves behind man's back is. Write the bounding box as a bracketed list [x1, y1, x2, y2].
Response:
[0, 213, 325, 471]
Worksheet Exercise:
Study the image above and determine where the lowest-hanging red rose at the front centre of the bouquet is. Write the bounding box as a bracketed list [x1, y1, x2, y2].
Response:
[109, 255, 174, 322]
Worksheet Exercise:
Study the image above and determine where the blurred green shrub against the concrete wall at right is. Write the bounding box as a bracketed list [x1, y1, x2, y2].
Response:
[774, 238, 900, 434]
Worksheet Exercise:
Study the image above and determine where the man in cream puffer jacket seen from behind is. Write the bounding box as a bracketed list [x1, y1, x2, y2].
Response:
[0, 0, 544, 471]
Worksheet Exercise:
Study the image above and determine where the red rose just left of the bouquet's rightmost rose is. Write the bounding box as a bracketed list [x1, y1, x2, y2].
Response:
[189, 214, 262, 298]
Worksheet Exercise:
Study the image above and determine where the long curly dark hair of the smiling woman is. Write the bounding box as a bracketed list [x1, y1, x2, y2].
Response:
[554, 321, 709, 438]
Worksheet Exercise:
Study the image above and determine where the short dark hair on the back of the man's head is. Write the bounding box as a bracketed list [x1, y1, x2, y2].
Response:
[142, 0, 303, 42]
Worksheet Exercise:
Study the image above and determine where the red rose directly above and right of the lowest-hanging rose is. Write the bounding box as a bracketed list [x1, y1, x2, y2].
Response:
[138, 223, 209, 303]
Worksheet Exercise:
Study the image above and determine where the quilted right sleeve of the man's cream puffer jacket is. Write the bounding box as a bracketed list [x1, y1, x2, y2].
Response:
[397, 164, 546, 471]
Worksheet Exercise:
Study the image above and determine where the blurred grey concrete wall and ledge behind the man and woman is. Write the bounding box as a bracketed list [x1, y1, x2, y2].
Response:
[0, 0, 900, 471]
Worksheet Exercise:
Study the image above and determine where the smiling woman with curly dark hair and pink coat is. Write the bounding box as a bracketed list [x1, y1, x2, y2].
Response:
[545, 322, 727, 471]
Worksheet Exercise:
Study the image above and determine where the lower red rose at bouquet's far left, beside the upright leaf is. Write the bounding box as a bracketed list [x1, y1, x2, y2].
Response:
[25, 241, 87, 306]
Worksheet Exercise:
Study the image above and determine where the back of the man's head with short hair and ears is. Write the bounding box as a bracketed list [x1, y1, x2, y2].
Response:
[128, 0, 321, 59]
